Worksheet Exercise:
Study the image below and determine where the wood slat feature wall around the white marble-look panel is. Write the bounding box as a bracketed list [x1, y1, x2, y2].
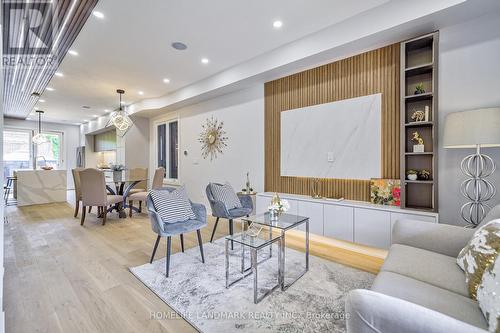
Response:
[264, 43, 400, 201]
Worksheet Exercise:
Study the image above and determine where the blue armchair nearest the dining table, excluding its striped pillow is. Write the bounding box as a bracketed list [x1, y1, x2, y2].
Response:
[146, 187, 207, 277]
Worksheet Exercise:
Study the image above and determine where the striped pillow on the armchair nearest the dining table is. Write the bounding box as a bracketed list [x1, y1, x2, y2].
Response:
[149, 187, 196, 223]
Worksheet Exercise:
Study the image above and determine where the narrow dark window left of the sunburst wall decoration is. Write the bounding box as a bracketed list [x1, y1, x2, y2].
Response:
[156, 120, 179, 180]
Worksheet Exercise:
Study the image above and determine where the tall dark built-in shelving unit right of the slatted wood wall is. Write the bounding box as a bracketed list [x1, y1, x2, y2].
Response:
[401, 32, 439, 212]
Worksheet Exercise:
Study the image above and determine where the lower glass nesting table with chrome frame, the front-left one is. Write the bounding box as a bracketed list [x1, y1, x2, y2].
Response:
[225, 231, 282, 304]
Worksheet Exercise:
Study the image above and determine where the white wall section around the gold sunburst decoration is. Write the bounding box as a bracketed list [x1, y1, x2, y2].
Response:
[150, 85, 264, 210]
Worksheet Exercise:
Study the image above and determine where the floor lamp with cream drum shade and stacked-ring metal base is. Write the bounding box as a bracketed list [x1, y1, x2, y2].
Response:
[443, 107, 500, 227]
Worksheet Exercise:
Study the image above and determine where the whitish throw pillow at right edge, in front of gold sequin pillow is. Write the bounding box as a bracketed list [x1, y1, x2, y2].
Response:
[477, 256, 500, 333]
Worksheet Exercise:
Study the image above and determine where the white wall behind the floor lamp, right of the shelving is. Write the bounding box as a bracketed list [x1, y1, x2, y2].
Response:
[439, 12, 500, 225]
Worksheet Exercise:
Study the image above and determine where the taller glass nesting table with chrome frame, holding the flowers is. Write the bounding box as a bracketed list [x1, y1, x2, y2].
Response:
[242, 212, 309, 290]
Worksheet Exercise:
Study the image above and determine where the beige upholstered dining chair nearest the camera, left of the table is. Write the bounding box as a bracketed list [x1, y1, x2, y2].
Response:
[79, 169, 123, 226]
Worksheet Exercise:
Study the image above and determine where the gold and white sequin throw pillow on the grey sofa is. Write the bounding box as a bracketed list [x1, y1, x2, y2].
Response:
[457, 220, 500, 299]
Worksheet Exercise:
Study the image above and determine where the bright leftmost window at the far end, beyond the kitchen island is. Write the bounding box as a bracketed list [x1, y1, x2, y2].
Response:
[3, 129, 33, 178]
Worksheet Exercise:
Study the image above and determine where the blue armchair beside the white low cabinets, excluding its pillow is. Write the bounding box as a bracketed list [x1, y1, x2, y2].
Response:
[205, 183, 253, 249]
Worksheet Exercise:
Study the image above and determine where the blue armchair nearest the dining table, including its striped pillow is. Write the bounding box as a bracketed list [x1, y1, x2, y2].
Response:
[146, 187, 207, 277]
